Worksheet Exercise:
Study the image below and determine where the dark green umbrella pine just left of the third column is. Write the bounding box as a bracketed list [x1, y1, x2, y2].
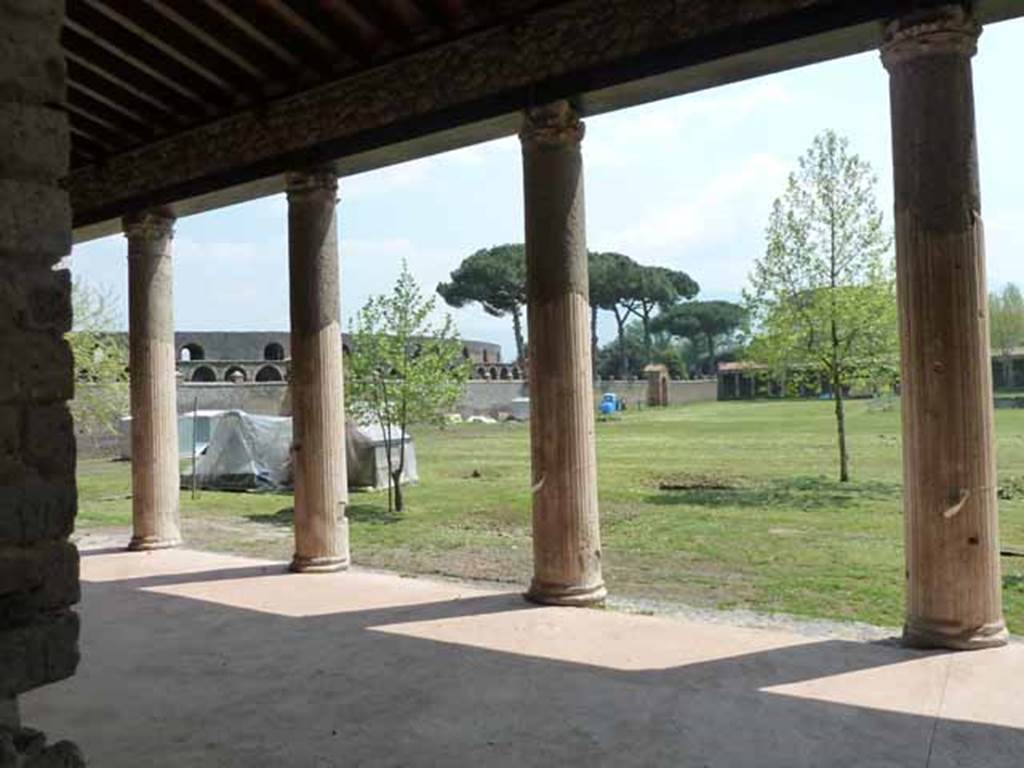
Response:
[437, 243, 526, 362]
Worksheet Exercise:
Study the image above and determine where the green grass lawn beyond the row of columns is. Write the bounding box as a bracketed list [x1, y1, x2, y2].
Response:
[78, 401, 1024, 633]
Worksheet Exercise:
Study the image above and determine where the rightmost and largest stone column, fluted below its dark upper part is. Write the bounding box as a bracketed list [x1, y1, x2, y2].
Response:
[882, 6, 1007, 648]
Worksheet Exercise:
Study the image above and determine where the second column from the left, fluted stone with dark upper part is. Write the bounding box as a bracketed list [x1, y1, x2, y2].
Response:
[287, 169, 348, 572]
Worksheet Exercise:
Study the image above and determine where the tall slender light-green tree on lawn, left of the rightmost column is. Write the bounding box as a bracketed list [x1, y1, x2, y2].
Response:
[744, 131, 897, 481]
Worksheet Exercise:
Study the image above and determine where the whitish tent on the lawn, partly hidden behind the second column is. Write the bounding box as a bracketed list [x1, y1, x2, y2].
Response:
[181, 411, 418, 490]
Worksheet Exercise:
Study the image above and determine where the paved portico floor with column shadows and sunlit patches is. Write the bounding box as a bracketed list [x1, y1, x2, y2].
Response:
[23, 550, 1024, 768]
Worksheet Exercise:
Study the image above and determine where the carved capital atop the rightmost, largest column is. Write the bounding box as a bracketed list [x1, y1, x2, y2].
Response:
[882, 5, 981, 69]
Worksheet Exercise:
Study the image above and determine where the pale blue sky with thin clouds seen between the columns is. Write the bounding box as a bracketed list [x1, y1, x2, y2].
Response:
[72, 19, 1024, 356]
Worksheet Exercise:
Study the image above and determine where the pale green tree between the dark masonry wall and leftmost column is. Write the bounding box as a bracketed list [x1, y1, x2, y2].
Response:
[67, 279, 129, 454]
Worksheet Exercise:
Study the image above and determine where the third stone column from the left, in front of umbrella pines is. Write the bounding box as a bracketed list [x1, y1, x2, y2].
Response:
[519, 101, 606, 605]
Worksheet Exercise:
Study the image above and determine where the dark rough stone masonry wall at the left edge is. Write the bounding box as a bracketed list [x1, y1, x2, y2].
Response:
[0, 0, 79, 766]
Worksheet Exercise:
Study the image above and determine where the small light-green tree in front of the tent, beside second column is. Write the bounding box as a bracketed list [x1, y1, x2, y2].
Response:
[346, 263, 470, 512]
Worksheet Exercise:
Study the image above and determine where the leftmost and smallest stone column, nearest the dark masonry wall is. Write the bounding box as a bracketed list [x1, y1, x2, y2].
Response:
[123, 211, 181, 550]
